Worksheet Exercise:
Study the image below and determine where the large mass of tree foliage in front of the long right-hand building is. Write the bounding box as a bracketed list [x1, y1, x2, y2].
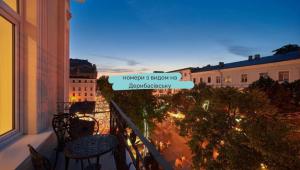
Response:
[172, 86, 300, 170]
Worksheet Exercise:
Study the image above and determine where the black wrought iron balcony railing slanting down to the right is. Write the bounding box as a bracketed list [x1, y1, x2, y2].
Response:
[110, 101, 172, 170]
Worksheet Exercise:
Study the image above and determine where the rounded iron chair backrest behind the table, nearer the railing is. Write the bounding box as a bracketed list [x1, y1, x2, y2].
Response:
[69, 116, 99, 140]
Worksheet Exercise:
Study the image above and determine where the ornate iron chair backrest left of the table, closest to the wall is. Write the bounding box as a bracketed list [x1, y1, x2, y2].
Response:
[52, 113, 71, 150]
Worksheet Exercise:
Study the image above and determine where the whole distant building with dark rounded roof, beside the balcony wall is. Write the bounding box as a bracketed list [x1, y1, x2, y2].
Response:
[69, 59, 97, 102]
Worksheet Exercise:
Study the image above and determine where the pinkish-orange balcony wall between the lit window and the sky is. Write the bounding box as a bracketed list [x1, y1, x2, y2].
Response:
[0, 0, 69, 141]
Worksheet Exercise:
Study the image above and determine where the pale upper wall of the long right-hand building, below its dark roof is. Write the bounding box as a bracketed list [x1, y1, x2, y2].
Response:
[191, 59, 300, 88]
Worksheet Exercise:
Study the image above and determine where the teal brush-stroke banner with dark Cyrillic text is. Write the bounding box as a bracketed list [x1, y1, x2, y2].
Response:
[108, 72, 194, 90]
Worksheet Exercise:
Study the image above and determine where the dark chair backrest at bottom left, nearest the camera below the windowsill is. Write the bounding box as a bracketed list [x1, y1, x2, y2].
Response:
[28, 145, 52, 170]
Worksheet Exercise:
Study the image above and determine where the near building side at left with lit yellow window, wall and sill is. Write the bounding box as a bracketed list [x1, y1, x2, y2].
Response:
[0, 0, 71, 169]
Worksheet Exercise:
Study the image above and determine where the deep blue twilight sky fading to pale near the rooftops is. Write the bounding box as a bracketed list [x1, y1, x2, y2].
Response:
[70, 0, 300, 74]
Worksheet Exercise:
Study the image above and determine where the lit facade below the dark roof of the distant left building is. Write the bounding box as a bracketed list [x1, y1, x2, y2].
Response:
[69, 78, 97, 102]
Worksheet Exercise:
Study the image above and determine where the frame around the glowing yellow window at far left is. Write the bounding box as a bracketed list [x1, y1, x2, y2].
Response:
[0, 0, 24, 145]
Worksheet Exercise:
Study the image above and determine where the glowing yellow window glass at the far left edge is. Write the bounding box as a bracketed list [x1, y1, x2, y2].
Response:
[0, 16, 14, 135]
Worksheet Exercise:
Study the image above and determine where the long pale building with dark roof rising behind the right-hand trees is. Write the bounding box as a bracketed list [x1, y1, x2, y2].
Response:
[154, 51, 300, 95]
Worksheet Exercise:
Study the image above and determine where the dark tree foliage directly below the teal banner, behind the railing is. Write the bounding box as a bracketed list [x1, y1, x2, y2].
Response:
[97, 77, 167, 130]
